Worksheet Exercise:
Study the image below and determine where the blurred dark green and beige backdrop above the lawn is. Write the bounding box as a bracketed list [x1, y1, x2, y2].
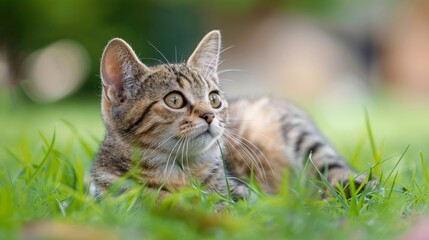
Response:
[0, 0, 429, 103]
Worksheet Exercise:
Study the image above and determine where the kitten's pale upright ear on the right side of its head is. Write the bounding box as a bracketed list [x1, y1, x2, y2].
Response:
[187, 30, 221, 81]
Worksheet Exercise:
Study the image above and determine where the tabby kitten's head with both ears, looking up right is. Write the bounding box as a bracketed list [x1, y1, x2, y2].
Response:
[101, 31, 228, 153]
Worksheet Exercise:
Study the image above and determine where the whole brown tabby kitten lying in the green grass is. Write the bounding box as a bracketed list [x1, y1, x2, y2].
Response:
[92, 31, 365, 199]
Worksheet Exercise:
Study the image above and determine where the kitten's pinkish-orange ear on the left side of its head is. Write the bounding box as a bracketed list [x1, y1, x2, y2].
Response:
[100, 38, 149, 102]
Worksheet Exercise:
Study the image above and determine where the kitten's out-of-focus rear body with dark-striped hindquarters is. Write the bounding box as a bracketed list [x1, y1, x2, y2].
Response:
[225, 98, 365, 194]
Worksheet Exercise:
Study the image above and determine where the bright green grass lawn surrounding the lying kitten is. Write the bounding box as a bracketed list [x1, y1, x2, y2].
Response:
[0, 91, 429, 239]
